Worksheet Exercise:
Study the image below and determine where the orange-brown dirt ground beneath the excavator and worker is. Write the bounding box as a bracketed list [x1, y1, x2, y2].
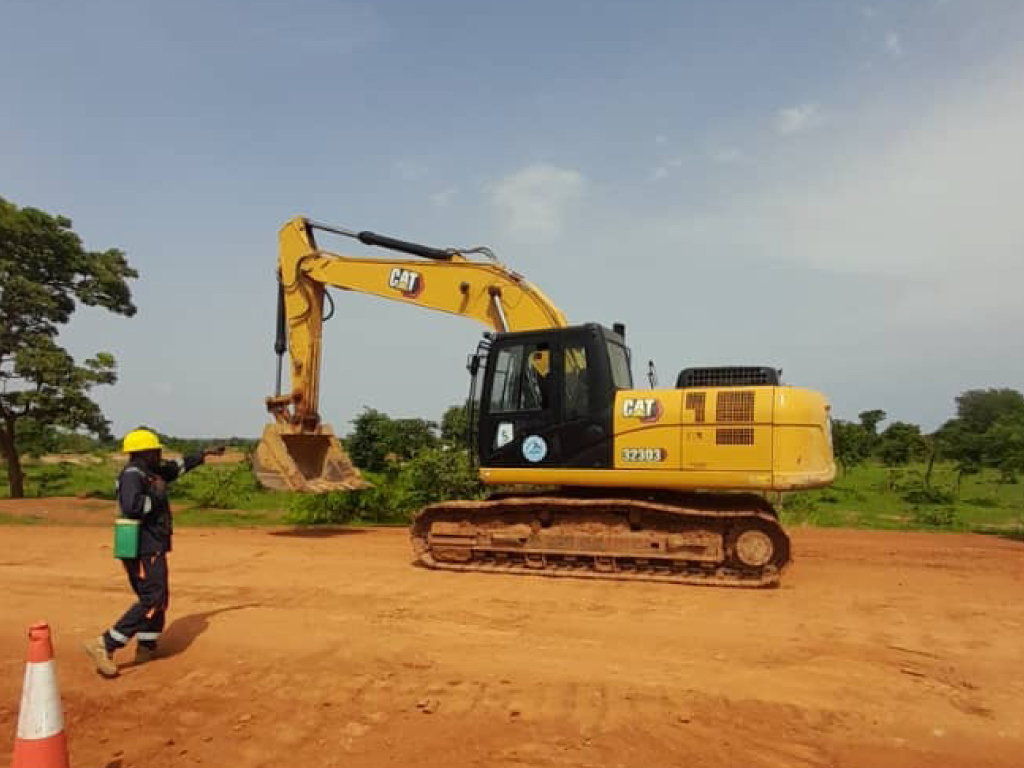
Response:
[0, 512, 1024, 768]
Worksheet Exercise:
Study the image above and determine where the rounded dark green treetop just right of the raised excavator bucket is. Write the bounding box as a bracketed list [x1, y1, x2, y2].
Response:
[345, 408, 438, 472]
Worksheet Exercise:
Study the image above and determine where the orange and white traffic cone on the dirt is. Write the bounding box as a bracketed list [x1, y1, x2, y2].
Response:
[11, 622, 69, 768]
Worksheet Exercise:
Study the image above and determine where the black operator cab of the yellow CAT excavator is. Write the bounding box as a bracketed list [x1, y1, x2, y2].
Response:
[471, 324, 633, 469]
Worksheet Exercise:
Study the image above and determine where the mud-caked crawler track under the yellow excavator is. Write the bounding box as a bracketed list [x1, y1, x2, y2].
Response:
[411, 493, 790, 587]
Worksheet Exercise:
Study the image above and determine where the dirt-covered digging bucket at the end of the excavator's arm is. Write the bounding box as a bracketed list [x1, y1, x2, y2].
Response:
[253, 424, 370, 494]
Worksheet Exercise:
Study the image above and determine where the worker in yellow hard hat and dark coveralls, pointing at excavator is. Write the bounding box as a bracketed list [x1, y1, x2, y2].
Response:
[85, 429, 224, 677]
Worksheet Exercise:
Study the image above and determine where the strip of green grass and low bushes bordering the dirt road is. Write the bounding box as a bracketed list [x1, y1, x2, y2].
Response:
[0, 451, 1024, 539]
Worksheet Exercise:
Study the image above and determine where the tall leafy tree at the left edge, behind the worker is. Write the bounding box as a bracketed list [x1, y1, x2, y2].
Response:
[0, 198, 138, 498]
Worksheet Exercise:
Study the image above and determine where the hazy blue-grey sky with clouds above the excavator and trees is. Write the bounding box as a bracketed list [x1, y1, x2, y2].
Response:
[0, 0, 1024, 436]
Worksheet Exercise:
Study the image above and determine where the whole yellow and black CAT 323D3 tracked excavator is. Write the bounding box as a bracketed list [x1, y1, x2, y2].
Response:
[254, 217, 836, 587]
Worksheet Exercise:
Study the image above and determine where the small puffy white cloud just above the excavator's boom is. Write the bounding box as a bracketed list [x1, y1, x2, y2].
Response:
[490, 163, 587, 237]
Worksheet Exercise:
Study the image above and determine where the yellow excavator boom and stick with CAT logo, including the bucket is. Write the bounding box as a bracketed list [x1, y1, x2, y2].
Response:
[249, 217, 567, 492]
